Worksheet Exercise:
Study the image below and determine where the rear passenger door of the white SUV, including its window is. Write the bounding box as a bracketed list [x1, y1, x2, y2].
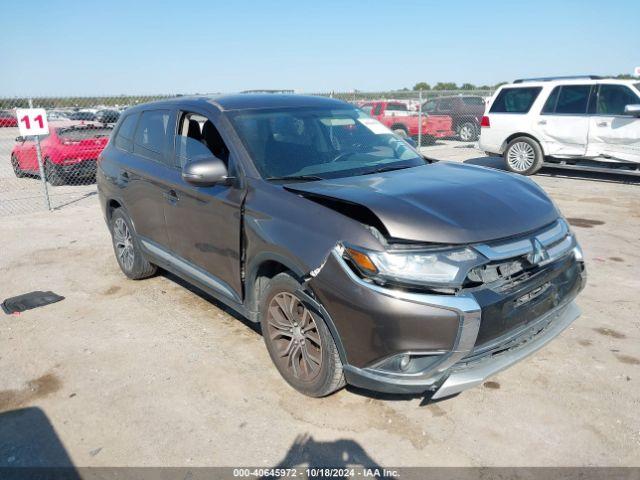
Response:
[533, 84, 595, 156]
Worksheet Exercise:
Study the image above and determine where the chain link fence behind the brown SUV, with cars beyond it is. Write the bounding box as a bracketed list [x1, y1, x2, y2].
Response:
[0, 90, 493, 216]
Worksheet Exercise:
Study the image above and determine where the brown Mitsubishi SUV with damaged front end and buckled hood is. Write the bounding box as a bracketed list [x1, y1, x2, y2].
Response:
[97, 94, 586, 398]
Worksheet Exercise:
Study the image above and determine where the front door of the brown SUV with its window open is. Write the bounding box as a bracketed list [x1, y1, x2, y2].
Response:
[165, 111, 243, 301]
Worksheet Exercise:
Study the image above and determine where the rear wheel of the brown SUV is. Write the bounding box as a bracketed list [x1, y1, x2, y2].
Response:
[109, 208, 158, 280]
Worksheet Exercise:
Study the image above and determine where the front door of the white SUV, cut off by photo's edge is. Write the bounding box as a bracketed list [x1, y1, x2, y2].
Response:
[588, 83, 640, 162]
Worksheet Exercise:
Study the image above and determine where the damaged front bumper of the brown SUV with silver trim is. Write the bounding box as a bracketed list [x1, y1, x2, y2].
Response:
[309, 250, 585, 399]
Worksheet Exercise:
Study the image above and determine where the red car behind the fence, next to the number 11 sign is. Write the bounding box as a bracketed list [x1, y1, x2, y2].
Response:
[11, 122, 112, 185]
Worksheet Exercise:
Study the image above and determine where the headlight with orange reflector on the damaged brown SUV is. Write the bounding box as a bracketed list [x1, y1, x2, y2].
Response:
[344, 247, 487, 287]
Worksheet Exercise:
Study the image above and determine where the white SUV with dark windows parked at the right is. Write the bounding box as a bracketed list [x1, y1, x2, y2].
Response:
[479, 76, 640, 175]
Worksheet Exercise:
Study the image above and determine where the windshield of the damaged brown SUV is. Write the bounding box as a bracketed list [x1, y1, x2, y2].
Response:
[231, 108, 425, 181]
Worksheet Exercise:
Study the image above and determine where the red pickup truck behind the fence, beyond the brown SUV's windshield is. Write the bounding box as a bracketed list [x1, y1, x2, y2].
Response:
[360, 101, 456, 145]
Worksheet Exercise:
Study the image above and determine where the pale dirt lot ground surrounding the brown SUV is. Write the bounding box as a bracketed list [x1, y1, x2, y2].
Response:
[0, 142, 640, 466]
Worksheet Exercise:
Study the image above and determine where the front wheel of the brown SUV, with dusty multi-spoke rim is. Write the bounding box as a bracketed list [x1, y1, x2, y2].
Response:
[260, 273, 345, 397]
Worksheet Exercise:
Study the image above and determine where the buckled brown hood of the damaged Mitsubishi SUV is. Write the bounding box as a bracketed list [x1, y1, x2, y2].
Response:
[286, 162, 559, 244]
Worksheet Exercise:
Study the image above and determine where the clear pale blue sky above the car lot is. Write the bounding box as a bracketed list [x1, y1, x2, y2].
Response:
[0, 0, 640, 96]
